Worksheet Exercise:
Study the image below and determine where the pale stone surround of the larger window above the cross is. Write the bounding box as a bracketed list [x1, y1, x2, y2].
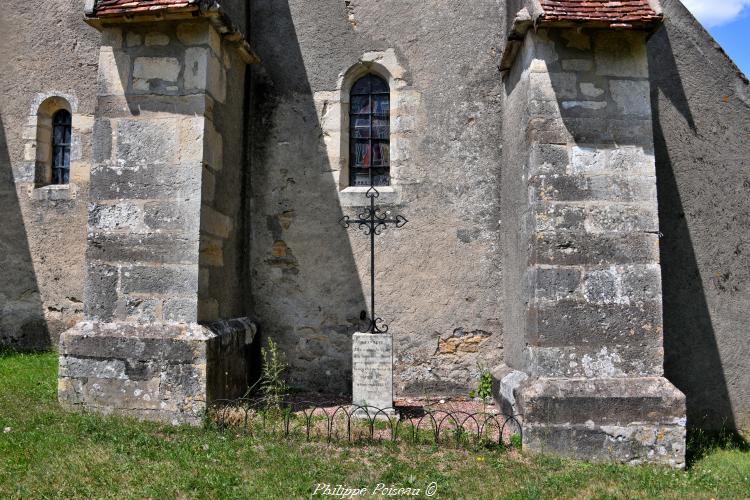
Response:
[314, 49, 420, 207]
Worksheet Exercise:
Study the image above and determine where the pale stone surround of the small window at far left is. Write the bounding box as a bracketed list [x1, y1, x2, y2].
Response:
[22, 92, 81, 201]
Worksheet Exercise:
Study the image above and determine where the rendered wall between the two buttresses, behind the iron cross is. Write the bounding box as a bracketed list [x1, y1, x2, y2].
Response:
[248, 0, 504, 396]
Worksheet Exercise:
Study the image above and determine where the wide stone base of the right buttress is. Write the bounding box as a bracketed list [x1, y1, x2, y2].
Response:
[493, 367, 686, 469]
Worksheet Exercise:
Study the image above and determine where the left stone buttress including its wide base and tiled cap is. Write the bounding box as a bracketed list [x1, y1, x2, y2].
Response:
[58, 2, 256, 424]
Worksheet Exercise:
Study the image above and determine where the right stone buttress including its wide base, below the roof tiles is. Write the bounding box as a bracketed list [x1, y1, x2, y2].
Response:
[494, 1, 685, 468]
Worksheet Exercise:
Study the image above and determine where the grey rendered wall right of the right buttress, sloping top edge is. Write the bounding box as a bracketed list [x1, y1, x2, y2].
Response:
[649, 0, 750, 429]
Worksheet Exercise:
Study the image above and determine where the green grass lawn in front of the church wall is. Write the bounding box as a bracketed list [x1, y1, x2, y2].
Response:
[0, 353, 750, 499]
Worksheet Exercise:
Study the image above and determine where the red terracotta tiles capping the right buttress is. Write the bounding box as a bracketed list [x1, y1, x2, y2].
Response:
[541, 0, 661, 24]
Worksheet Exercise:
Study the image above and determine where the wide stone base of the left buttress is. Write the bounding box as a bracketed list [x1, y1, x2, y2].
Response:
[58, 318, 256, 425]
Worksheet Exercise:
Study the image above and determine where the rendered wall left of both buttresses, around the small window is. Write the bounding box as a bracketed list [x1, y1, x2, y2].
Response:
[0, 0, 100, 348]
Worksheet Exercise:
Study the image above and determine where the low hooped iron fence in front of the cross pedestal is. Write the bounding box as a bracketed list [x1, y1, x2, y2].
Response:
[207, 398, 522, 448]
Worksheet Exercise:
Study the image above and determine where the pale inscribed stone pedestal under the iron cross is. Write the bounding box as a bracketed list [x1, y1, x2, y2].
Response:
[352, 333, 395, 417]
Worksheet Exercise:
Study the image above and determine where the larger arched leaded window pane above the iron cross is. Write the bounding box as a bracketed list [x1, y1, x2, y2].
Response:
[349, 75, 391, 186]
